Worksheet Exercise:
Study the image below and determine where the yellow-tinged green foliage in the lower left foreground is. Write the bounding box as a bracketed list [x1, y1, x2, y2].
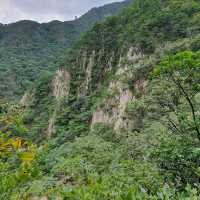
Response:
[0, 105, 39, 199]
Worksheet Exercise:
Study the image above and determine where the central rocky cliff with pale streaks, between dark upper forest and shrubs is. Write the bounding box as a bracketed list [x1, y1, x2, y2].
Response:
[63, 35, 199, 138]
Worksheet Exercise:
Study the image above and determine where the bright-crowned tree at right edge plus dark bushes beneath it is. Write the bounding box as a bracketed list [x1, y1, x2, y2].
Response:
[148, 51, 200, 187]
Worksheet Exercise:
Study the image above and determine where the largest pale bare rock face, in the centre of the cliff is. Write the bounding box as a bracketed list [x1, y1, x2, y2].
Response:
[91, 47, 147, 132]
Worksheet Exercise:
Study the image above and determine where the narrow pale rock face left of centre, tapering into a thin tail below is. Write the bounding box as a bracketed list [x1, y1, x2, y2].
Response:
[47, 69, 71, 138]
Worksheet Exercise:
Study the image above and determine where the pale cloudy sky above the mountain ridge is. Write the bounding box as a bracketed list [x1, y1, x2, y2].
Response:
[0, 0, 122, 24]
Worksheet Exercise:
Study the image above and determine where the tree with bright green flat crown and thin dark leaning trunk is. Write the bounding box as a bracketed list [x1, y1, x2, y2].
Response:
[152, 51, 200, 140]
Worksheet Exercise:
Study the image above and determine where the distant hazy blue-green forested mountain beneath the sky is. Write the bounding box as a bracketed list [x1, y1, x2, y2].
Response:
[0, 1, 130, 99]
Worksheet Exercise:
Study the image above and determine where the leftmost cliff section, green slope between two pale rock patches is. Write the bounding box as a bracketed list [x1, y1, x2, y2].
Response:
[20, 69, 71, 140]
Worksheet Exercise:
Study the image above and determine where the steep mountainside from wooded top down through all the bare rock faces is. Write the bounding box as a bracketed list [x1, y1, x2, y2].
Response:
[23, 0, 199, 141]
